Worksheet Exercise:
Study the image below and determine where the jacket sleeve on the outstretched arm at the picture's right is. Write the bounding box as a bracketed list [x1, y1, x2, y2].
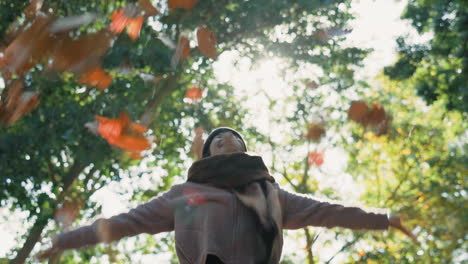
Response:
[279, 189, 389, 229]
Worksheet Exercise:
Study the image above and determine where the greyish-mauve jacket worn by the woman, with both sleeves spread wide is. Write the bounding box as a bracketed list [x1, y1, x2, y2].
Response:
[55, 182, 389, 264]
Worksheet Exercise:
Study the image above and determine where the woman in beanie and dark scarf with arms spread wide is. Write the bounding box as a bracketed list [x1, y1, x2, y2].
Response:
[39, 128, 414, 264]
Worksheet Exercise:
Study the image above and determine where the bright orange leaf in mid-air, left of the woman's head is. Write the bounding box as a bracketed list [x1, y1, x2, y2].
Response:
[95, 113, 151, 159]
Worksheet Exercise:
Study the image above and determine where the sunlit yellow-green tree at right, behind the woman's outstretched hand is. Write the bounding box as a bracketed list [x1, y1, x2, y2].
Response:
[344, 77, 467, 263]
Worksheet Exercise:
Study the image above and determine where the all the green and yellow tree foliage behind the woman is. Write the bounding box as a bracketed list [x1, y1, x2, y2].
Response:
[0, 0, 468, 264]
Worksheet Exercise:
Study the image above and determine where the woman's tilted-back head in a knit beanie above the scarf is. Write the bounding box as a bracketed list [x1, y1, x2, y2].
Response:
[203, 127, 247, 158]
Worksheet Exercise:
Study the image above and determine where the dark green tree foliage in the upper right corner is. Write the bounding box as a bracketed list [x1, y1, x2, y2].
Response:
[385, 0, 468, 113]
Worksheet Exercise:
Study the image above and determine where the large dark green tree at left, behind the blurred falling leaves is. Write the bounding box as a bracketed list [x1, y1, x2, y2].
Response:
[0, 0, 365, 263]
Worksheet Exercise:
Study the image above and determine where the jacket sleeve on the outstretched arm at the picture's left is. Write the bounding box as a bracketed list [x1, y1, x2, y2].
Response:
[54, 188, 175, 249]
